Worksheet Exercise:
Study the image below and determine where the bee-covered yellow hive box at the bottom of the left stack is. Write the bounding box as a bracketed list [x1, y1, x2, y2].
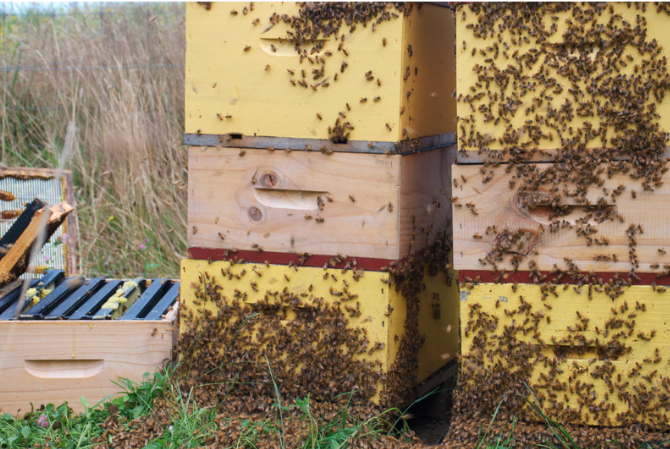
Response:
[181, 259, 458, 405]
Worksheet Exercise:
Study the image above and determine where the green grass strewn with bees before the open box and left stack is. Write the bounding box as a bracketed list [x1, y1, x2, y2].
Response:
[0, 370, 414, 449]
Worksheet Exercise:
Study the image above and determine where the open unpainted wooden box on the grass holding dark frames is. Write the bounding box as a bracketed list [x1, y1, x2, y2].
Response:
[0, 270, 179, 414]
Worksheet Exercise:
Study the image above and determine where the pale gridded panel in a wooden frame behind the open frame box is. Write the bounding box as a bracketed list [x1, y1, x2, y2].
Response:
[0, 177, 67, 278]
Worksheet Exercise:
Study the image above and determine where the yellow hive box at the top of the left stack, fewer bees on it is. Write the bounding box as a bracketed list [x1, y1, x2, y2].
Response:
[185, 2, 456, 152]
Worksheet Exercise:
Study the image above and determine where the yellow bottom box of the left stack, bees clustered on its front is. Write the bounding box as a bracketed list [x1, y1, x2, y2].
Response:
[180, 259, 458, 405]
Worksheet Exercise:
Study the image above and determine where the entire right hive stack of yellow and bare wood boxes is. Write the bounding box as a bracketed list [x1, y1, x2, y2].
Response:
[452, 3, 670, 447]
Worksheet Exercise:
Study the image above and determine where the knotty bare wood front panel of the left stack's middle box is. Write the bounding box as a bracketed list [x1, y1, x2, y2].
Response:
[188, 147, 405, 259]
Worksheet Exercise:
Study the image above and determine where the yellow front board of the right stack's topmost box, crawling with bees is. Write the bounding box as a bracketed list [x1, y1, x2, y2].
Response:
[456, 2, 670, 155]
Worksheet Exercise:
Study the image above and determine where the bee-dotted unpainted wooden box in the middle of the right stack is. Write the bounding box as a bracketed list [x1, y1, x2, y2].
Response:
[453, 165, 670, 273]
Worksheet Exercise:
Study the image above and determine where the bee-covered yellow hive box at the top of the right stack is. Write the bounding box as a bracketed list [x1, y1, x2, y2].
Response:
[455, 2, 670, 159]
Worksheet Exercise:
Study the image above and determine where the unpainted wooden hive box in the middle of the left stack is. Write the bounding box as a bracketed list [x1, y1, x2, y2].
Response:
[188, 146, 455, 260]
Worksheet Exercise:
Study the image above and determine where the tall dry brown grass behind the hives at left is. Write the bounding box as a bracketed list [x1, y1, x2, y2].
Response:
[0, 3, 186, 277]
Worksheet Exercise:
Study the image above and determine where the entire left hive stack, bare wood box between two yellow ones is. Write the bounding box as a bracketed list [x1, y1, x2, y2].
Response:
[181, 3, 458, 405]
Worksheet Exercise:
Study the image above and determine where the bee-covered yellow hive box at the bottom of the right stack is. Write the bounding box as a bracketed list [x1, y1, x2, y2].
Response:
[459, 284, 670, 427]
